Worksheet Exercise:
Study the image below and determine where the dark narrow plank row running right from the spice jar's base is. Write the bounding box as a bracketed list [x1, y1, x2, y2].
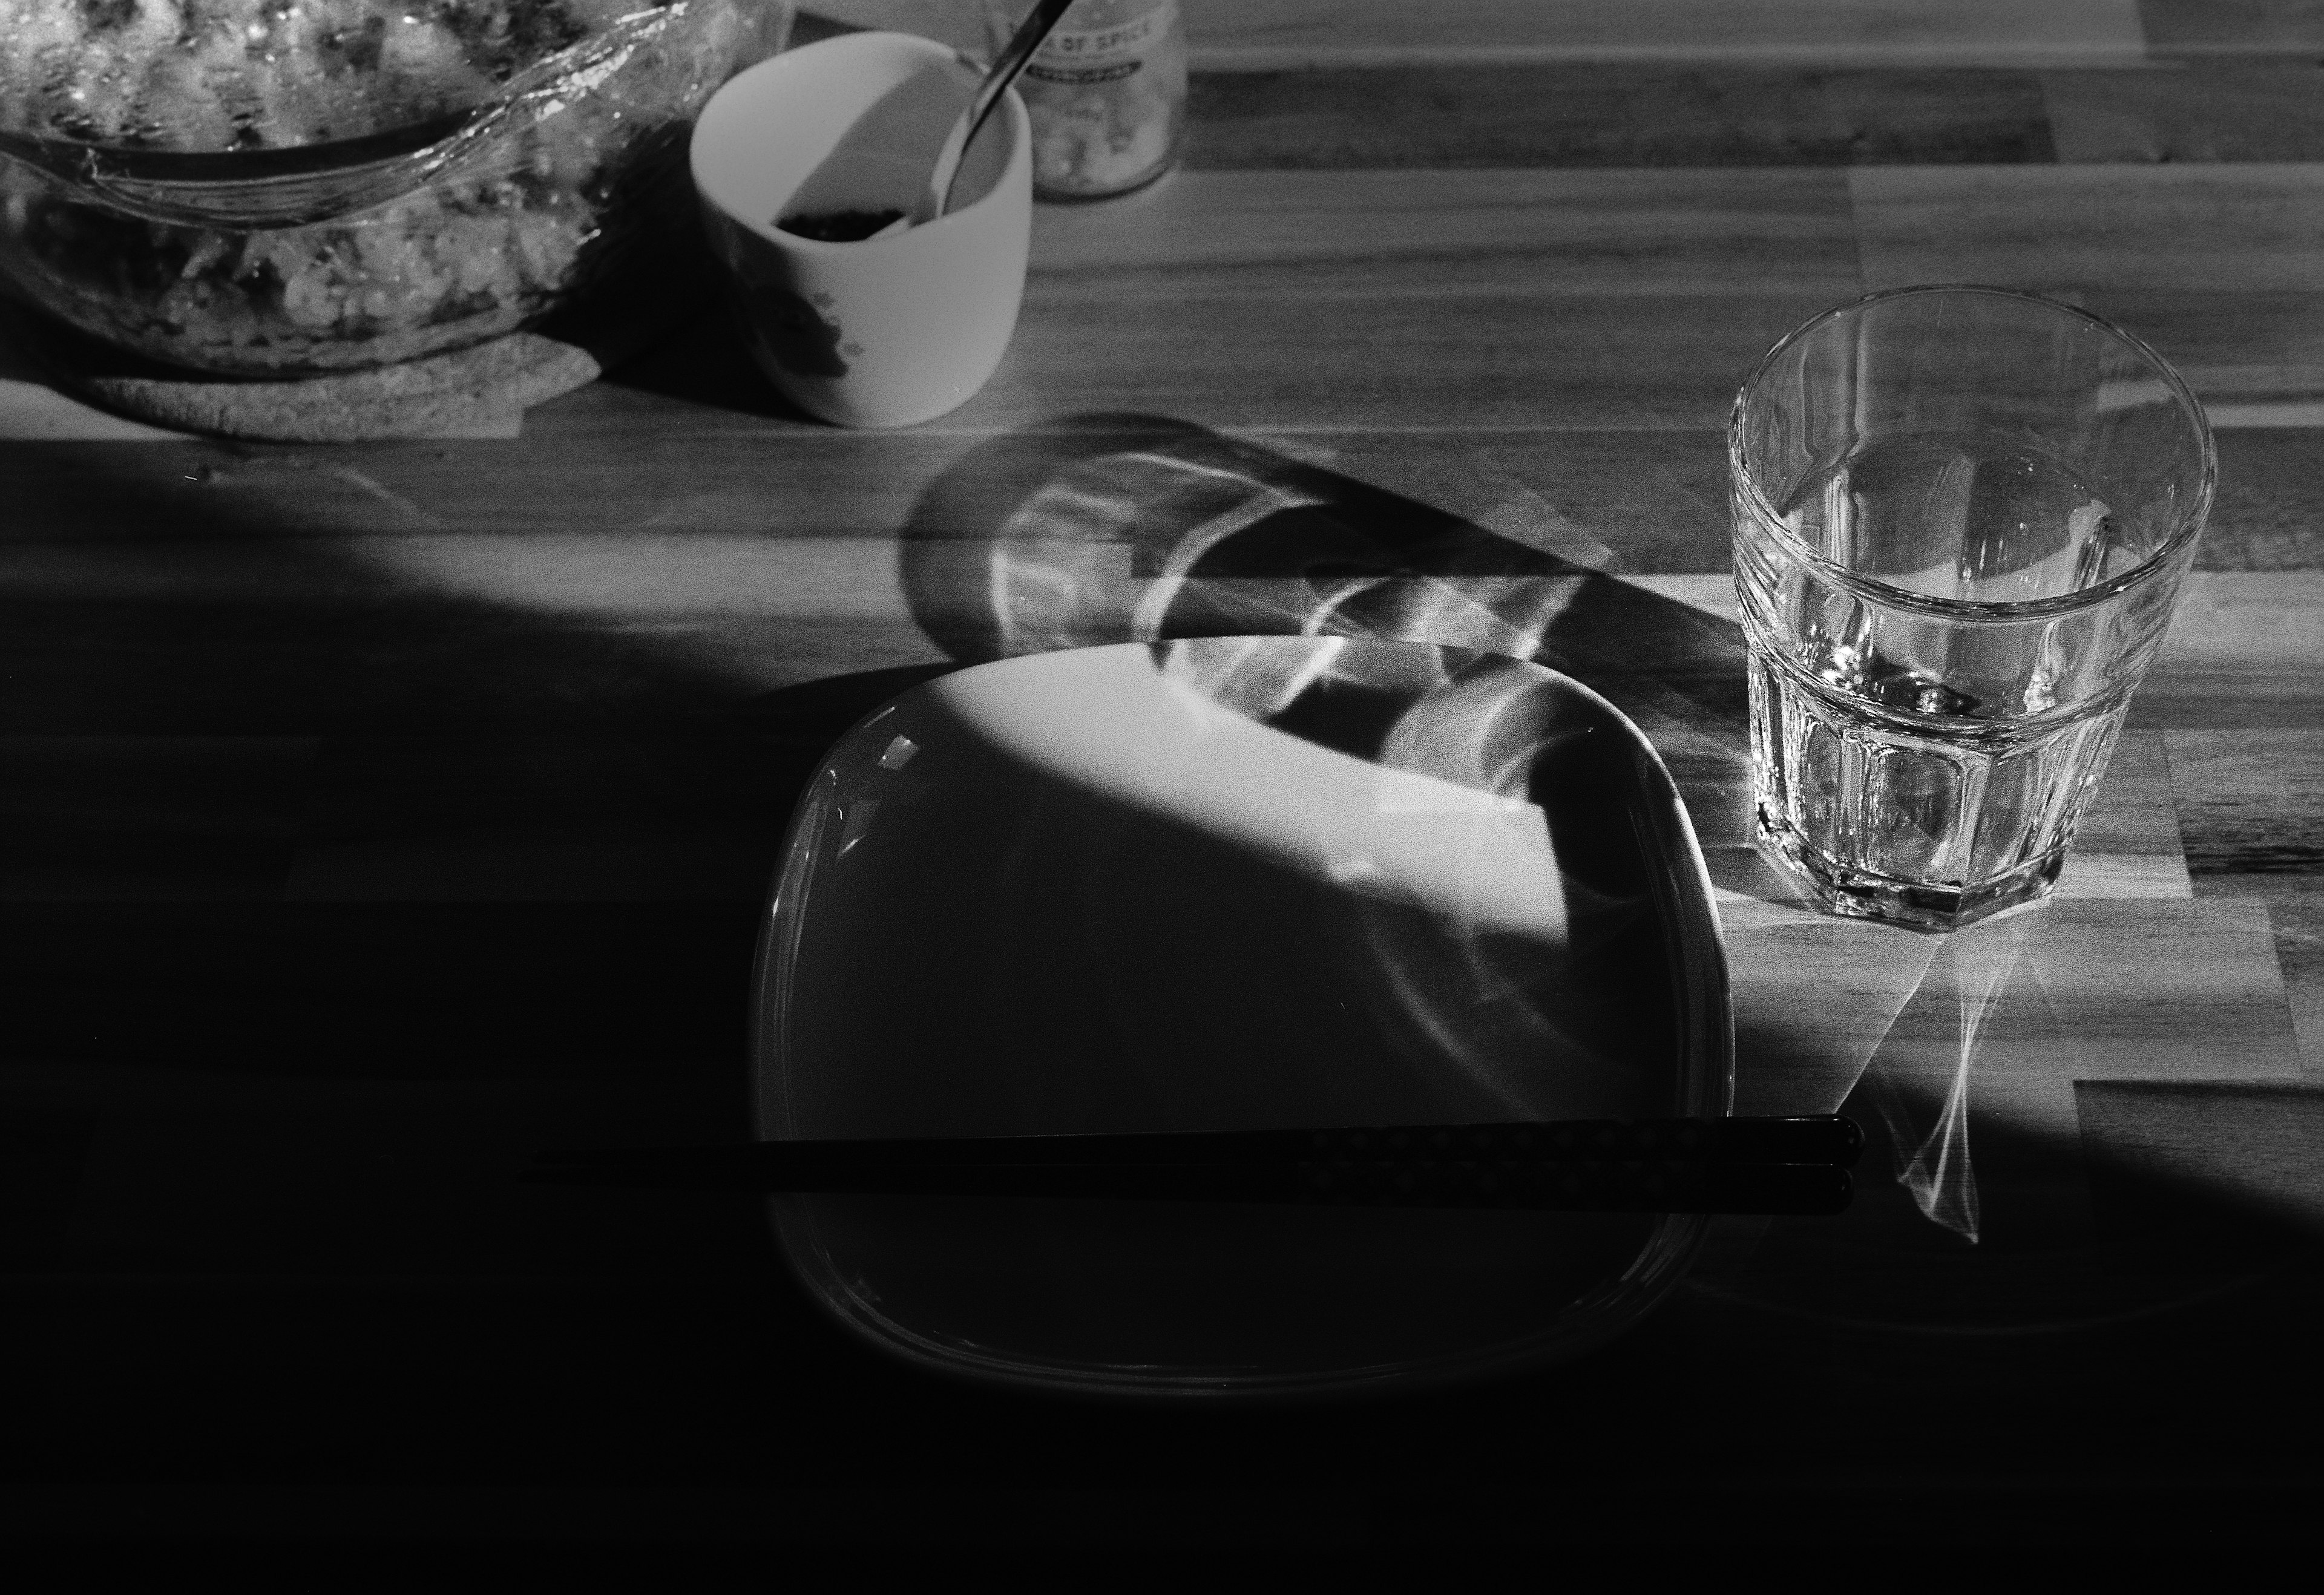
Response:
[1185, 58, 2324, 170]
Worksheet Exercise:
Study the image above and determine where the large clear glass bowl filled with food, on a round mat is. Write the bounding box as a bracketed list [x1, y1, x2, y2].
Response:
[0, 0, 792, 376]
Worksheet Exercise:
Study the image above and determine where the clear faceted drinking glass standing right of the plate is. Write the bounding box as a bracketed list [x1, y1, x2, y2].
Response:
[1727, 286, 2217, 930]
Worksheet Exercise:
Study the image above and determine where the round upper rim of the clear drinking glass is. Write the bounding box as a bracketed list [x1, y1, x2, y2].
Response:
[1727, 284, 2219, 621]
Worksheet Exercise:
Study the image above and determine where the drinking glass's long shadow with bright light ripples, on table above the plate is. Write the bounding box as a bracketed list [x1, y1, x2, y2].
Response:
[902, 414, 1757, 860]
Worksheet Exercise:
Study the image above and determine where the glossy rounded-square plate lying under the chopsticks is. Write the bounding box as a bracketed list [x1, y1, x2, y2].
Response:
[753, 637, 1732, 1395]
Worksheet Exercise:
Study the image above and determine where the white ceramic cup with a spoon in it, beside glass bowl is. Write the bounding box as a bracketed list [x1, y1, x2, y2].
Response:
[692, 33, 1032, 425]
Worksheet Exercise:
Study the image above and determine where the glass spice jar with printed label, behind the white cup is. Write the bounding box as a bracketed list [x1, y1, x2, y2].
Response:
[985, 0, 1185, 200]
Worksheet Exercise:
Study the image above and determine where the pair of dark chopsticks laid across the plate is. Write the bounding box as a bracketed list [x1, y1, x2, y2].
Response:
[525, 1116, 1864, 1214]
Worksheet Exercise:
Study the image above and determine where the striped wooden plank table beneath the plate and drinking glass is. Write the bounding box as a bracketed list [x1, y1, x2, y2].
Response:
[0, 0, 2324, 1556]
